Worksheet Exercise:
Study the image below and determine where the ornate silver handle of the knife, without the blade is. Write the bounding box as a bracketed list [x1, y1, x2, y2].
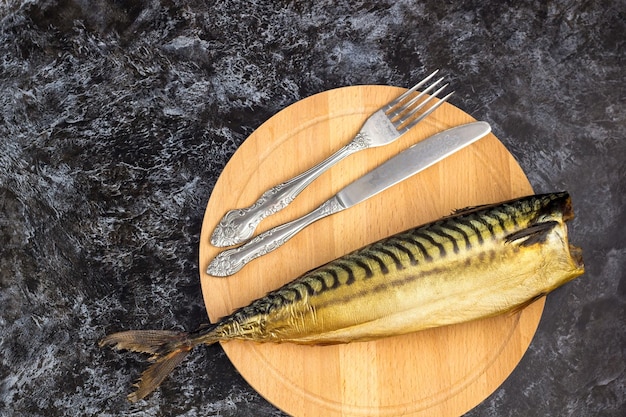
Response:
[207, 197, 344, 277]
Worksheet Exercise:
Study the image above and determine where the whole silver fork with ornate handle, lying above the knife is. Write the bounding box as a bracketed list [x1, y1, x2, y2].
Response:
[211, 70, 453, 247]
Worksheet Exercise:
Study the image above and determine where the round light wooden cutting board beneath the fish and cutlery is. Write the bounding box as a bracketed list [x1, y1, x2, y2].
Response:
[200, 86, 544, 417]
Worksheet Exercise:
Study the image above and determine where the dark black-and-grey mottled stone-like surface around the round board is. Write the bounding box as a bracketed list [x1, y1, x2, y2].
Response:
[0, 0, 626, 417]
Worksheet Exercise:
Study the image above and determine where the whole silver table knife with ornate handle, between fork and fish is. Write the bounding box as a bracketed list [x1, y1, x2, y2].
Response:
[207, 122, 491, 277]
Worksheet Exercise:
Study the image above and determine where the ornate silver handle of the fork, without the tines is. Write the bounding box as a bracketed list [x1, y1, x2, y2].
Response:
[211, 133, 369, 247]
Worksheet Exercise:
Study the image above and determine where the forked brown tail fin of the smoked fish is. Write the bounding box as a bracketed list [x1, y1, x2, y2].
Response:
[100, 330, 197, 402]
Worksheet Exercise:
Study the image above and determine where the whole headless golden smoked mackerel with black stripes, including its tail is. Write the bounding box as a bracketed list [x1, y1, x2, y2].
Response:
[100, 191, 585, 402]
